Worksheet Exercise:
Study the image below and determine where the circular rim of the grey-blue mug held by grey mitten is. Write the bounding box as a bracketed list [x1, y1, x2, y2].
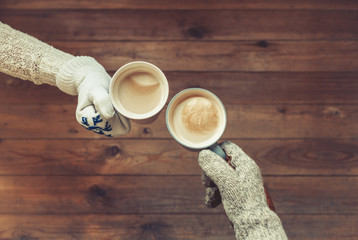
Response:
[165, 87, 227, 150]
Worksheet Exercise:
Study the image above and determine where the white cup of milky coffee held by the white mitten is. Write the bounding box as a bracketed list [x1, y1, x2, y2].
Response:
[109, 61, 169, 124]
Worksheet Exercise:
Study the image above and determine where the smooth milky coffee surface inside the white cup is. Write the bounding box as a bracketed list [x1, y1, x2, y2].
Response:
[118, 72, 161, 114]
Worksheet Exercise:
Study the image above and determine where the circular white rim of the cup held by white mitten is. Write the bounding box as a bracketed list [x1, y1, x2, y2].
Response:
[109, 61, 169, 120]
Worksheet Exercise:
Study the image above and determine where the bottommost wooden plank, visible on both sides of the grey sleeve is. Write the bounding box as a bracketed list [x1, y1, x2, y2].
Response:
[0, 214, 358, 240]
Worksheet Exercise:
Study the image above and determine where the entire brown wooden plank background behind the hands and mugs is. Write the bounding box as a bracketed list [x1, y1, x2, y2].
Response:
[0, 0, 358, 240]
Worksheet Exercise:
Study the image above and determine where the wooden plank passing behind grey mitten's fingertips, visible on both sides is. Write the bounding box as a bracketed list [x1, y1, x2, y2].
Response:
[0, 139, 358, 176]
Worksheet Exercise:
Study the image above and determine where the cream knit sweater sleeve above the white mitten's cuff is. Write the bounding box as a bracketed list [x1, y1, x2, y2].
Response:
[0, 22, 74, 85]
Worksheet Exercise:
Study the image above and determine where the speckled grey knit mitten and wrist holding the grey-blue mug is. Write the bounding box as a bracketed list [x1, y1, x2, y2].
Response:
[198, 142, 287, 240]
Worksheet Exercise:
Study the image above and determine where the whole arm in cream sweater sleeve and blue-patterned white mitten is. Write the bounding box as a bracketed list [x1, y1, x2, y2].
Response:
[0, 22, 130, 136]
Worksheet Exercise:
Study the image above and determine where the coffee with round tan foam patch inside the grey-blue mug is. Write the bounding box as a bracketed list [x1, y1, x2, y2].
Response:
[173, 96, 220, 143]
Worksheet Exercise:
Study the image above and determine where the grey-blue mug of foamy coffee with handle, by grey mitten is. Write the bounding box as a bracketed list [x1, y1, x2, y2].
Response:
[165, 88, 227, 154]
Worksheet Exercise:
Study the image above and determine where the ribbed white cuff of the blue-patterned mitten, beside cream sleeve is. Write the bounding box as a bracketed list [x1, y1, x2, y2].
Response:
[56, 56, 106, 95]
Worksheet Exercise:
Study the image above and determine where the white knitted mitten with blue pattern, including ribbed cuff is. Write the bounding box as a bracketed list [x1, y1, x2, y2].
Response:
[56, 57, 130, 136]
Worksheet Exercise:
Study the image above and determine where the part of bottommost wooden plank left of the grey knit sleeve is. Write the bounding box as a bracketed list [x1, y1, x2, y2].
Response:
[0, 214, 235, 240]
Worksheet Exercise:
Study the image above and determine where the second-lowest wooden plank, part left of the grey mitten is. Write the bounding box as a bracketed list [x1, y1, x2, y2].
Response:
[0, 175, 222, 215]
